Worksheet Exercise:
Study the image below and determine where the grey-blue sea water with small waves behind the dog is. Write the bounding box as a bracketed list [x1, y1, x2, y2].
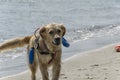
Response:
[0, 0, 120, 77]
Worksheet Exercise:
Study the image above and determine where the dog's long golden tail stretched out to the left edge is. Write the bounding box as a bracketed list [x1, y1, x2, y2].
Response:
[0, 36, 32, 52]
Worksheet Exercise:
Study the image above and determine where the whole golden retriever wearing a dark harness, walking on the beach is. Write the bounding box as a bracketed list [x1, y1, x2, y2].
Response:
[0, 23, 66, 80]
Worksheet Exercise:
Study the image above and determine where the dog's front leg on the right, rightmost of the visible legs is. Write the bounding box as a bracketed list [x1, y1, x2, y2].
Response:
[52, 58, 61, 80]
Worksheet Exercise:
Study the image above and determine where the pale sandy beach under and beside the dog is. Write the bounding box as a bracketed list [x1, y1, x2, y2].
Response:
[0, 43, 120, 80]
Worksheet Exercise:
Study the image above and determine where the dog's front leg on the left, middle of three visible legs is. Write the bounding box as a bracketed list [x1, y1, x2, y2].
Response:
[40, 64, 49, 80]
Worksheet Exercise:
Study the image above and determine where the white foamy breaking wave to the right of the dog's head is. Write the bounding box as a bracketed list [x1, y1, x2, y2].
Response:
[65, 25, 120, 42]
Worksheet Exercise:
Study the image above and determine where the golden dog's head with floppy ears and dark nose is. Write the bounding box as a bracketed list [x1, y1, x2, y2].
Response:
[39, 23, 66, 46]
